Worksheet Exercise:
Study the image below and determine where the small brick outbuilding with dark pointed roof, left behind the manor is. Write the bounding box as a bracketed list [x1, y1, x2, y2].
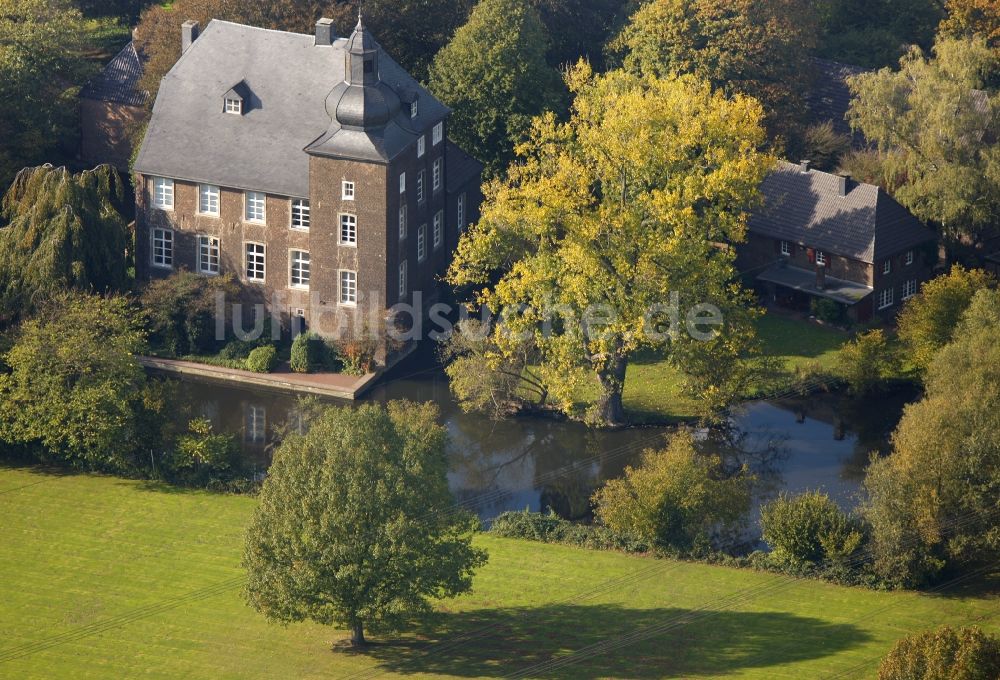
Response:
[80, 43, 149, 170]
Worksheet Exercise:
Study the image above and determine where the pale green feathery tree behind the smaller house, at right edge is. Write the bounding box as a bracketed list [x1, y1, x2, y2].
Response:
[849, 39, 1000, 239]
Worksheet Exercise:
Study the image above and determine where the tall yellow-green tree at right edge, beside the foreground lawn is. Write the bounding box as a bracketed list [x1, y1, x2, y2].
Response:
[865, 290, 1000, 586]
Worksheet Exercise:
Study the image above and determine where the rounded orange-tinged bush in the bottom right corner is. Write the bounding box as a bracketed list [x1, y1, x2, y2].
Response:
[878, 626, 1000, 680]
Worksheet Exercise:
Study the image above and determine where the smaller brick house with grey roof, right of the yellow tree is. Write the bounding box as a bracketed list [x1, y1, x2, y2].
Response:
[738, 161, 937, 320]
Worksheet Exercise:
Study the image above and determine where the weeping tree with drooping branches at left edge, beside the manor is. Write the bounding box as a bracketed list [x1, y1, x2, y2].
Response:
[0, 165, 129, 322]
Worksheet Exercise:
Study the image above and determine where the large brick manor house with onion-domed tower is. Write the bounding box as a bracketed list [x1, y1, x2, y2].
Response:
[135, 19, 481, 348]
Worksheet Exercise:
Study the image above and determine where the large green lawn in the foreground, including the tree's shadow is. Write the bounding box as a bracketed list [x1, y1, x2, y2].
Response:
[0, 468, 1000, 679]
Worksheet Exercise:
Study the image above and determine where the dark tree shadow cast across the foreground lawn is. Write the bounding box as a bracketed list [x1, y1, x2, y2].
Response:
[366, 604, 870, 678]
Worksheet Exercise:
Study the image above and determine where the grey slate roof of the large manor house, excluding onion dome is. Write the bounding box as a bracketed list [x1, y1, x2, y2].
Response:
[135, 20, 449, 198]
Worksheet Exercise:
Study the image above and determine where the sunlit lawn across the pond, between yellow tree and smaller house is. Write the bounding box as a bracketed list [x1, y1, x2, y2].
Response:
[624, 314, 849, 422]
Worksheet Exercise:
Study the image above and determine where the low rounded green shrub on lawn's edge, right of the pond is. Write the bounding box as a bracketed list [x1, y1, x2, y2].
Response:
[760, 491, 862, 566]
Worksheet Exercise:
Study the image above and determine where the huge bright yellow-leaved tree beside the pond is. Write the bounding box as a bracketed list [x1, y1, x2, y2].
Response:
[448, 65, 773, 424]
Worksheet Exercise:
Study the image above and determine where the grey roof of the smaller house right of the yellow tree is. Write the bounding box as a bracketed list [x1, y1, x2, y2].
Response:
[747, 163, 936, 263]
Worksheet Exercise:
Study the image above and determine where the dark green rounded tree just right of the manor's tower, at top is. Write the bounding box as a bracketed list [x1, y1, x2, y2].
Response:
[430, 0, 561, 176]
